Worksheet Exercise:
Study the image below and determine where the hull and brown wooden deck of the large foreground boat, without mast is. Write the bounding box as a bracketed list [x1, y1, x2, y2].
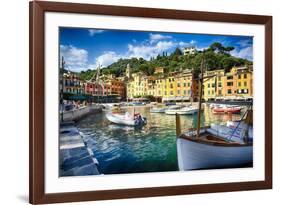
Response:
[177, 129, 253, 171]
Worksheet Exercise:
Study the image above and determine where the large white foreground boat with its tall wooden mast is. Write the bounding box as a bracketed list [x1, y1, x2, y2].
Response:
[176, 56, 253, 171]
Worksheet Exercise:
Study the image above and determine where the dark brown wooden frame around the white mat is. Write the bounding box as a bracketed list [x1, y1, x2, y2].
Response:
[29, 1, 272, 204]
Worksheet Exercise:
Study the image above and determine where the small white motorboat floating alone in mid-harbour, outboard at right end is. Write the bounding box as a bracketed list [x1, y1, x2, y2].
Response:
[106, 112, 147, 126]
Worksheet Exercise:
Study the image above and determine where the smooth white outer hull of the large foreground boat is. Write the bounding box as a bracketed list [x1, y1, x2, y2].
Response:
[177, 137, 253, 171]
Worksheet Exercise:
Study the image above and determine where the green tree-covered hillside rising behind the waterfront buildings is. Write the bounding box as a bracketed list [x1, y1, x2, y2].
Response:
[76, 42, 252, 80]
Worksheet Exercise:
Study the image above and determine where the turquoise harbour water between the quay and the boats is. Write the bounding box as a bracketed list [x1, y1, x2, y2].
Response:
[77, 107, 240, 174]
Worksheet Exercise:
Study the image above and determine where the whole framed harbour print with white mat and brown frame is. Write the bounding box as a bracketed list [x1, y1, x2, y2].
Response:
[30, 1, 272, 204]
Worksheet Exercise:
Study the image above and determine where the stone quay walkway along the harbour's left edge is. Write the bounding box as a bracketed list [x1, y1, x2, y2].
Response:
[59, 106, 102, 177]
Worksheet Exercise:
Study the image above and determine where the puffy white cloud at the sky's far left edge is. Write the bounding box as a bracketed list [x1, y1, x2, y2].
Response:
[60, 45, 88, 71]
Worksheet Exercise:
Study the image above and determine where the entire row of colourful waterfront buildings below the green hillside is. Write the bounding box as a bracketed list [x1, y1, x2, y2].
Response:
[63, 65, 253, 102]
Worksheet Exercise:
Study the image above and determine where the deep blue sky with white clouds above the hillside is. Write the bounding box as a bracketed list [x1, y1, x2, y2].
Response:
[59, 28, 253, 72]
